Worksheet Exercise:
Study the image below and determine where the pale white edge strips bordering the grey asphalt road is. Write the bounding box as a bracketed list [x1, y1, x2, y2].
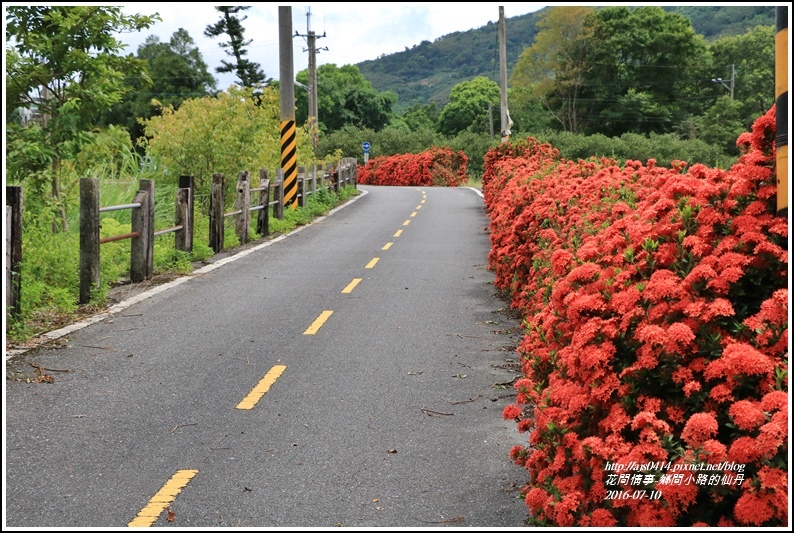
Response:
[6, 187, 482, 361]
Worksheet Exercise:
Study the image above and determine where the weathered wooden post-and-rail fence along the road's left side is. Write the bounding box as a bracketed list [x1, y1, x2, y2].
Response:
[6, 157, 357, 316]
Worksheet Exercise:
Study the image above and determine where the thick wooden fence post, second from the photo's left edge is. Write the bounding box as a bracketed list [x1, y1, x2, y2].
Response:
[79, 178, 101, 304]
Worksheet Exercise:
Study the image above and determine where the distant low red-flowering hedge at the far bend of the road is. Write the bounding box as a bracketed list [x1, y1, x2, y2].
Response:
[356, 147, 469, 187]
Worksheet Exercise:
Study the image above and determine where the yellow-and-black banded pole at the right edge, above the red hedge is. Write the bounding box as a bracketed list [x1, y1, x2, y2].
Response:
[775, 6, 789, 217]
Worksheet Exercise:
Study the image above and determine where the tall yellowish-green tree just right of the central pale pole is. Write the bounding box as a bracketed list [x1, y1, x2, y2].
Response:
[510, 6, 594, 133]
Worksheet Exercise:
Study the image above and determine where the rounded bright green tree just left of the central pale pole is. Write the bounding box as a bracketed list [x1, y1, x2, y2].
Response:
[438, 76, 501, 135]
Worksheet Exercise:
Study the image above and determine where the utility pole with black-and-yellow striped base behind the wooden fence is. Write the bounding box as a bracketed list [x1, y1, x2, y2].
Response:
[278, 6, 298, 209]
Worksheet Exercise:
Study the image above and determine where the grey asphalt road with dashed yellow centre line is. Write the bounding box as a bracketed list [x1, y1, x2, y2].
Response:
[3, 186, 527, 528]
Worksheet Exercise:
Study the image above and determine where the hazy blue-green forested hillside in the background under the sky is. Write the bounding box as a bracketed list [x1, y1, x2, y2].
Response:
[356, 6, 775, 112]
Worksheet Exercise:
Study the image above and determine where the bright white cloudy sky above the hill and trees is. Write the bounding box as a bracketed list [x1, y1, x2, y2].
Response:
[116, 2, 545, 89]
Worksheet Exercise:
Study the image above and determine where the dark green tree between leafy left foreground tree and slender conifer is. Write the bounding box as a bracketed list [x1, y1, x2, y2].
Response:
[104, 28, 216, 141]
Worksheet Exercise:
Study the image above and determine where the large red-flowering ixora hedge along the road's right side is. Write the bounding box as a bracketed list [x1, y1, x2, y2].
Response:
[483, 108, 789, 527]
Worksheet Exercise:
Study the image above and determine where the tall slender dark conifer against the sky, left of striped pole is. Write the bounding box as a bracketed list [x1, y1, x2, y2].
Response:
[204, 6, 272, 87]
